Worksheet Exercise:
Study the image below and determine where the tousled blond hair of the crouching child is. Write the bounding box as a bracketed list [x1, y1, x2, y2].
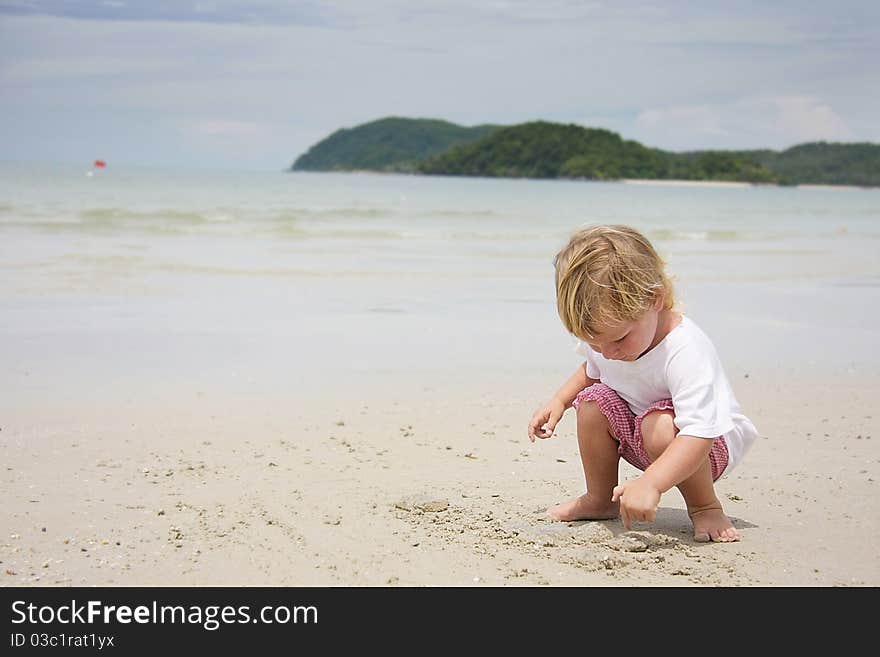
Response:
[553, 226, 675, 340]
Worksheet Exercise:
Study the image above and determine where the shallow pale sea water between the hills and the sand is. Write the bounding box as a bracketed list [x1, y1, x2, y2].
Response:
[0, 164, 880, 407]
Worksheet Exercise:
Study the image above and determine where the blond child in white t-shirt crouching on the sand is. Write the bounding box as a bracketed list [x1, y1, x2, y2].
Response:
[529, 226, 757, 542]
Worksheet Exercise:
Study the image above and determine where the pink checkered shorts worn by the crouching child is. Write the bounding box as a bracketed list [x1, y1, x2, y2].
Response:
[572, 383, 728, 480]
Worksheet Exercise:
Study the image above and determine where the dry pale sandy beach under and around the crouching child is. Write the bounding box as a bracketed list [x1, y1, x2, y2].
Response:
[0, 364, 880, 586]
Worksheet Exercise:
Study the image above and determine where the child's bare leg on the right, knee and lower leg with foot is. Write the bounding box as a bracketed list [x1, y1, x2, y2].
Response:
[641, 411, 739, 543]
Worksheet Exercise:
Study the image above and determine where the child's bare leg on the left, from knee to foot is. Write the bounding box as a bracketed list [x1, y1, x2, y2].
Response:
[547, 402, 620, 520]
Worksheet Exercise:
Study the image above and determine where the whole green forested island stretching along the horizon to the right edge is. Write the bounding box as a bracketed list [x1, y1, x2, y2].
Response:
[291, 117, 880, 187]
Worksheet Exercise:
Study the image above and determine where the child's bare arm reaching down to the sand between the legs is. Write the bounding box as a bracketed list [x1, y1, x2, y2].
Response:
[611, 434, 712, 529]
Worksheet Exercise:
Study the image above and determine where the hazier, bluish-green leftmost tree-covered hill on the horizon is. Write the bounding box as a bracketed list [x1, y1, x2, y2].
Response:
[291, 117, 499, 172]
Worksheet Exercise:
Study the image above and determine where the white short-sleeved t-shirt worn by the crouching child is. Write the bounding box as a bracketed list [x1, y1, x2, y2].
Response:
[576, 316, 758, 474]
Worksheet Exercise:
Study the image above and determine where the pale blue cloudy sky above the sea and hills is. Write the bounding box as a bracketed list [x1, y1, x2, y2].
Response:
[0, 0, 880, 170]
